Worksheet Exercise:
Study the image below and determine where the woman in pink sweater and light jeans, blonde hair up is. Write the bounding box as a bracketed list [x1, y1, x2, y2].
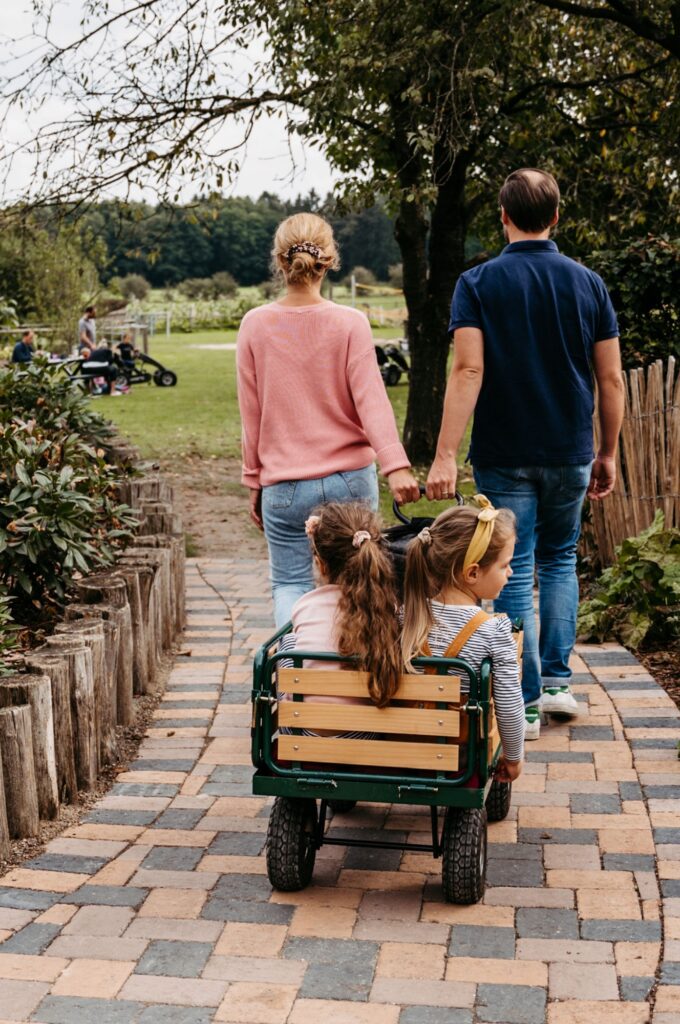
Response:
[237, 213, 420, 627]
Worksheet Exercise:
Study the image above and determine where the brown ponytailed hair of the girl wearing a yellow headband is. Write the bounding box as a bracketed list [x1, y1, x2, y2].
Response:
[401, 505, 515, 671]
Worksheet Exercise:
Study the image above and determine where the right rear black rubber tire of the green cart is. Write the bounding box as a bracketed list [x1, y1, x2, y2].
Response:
[441, 807, 486, 904]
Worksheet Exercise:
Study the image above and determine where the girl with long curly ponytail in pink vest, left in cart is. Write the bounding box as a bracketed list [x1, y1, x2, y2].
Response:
[280, 502, 402, 735]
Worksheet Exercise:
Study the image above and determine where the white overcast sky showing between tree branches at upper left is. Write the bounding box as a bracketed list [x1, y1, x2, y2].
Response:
[0, 0, 334, 202]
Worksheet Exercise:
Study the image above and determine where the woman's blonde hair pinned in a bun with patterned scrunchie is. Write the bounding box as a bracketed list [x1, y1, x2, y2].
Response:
[271, 213, 340, 285]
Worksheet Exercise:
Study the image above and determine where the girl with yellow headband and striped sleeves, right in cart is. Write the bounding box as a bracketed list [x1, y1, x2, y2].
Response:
[401, 495, 524, 782]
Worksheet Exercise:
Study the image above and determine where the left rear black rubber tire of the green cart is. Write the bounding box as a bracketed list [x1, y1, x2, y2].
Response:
[266, 797, 316, 893]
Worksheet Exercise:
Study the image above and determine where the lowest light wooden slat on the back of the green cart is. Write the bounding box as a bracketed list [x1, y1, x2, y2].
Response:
[279, 736, 458, 771]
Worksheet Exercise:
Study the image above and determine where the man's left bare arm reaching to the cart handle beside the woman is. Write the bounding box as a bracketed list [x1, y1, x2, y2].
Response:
[426, 327, 484, 501]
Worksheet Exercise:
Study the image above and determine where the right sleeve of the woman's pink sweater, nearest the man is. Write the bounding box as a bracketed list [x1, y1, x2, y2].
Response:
[347, 315, 411, 476]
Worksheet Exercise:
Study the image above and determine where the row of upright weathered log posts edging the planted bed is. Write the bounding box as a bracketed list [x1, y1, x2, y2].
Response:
[0, 468, 185, 859]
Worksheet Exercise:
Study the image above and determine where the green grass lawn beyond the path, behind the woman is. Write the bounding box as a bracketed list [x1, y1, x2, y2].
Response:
[104, 328, 469, 520]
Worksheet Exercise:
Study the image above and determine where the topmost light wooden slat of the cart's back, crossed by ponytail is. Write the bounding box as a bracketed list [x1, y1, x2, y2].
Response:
[278, 669, 461, 703]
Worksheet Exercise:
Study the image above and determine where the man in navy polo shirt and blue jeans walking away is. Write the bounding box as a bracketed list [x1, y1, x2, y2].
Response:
[427, 168, 624, 739]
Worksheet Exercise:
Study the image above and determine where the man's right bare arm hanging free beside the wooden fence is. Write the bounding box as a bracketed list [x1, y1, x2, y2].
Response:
[588, 338, 624, 501]
